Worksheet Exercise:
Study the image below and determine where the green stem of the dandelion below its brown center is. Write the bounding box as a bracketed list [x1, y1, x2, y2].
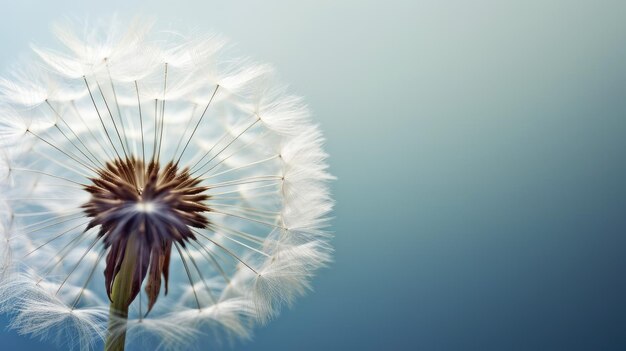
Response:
[104, 235, 137, 351]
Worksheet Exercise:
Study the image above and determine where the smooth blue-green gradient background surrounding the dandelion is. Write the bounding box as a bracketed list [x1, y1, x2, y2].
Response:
[0, 0, 626, 350]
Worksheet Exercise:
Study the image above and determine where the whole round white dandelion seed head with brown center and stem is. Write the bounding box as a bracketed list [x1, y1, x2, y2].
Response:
[0, 18, 332, 350]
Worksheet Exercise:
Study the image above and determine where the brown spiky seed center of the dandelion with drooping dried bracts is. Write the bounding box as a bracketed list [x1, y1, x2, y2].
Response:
[83, 158, 210, 310]
